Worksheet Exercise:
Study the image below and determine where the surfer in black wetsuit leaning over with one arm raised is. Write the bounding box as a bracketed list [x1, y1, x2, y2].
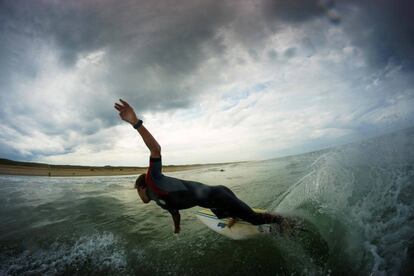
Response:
[114, 99, 284, 233]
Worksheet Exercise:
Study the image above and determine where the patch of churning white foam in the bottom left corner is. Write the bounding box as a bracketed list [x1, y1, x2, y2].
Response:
[0, 232, 127, 275]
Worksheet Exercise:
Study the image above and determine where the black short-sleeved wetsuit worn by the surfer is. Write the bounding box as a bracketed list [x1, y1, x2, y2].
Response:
[145, 158, 280, 225]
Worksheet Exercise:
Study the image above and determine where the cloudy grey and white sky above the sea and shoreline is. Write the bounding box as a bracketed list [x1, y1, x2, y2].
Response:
[0, 0, 414, 165]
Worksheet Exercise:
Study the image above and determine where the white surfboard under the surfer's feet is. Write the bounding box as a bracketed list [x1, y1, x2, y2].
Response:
[194, 208, 279, 240]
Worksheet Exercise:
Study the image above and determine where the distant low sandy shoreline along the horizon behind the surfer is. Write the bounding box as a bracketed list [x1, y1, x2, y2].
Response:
[0, 158, 230, 177]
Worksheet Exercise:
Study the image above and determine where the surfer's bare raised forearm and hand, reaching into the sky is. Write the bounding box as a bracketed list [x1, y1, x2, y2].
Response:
[114, 99, 161, 158]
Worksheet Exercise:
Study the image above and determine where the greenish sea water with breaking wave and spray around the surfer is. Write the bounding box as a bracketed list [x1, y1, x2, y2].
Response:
[0, 129, 414, 275]
